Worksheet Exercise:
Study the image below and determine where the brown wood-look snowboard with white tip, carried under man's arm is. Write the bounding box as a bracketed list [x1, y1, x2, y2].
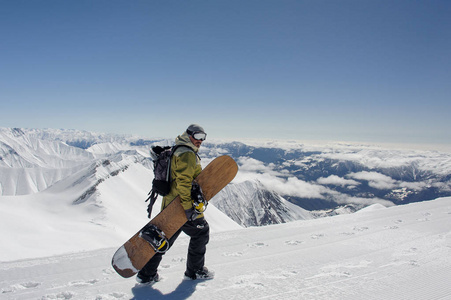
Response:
[111, 155, 238, 278]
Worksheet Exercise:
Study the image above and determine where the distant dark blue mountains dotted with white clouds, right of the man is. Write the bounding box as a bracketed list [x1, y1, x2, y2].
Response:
[202, 142, 451, 210]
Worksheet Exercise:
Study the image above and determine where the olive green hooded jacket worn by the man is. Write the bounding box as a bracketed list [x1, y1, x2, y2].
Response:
[161, 132, 203, 218]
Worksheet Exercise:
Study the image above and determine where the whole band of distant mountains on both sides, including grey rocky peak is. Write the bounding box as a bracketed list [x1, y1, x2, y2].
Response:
[0, 128, 451, 226]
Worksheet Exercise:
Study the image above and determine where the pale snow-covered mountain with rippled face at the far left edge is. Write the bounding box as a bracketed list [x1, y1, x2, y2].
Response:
[0, 128, 94, 195]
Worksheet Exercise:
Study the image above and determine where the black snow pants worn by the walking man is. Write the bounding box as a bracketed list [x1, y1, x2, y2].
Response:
[139, 218, 210, 277]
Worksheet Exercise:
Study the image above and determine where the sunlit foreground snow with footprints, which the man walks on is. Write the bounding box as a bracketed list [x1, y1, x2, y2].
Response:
[0, 197, 451, 300]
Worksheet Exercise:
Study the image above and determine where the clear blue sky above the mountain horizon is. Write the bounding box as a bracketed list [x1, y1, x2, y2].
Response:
[0, 0, 451, 144]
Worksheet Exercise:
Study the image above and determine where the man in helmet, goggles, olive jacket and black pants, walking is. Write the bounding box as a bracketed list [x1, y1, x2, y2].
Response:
[136, 124, 214, 283]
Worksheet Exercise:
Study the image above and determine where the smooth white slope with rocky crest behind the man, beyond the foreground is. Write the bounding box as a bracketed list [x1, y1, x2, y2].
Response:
[0, 157, 241, 261]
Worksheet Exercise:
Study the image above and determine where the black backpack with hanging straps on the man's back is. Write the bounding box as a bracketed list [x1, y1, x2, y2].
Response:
[146, 145, 194, 219]
